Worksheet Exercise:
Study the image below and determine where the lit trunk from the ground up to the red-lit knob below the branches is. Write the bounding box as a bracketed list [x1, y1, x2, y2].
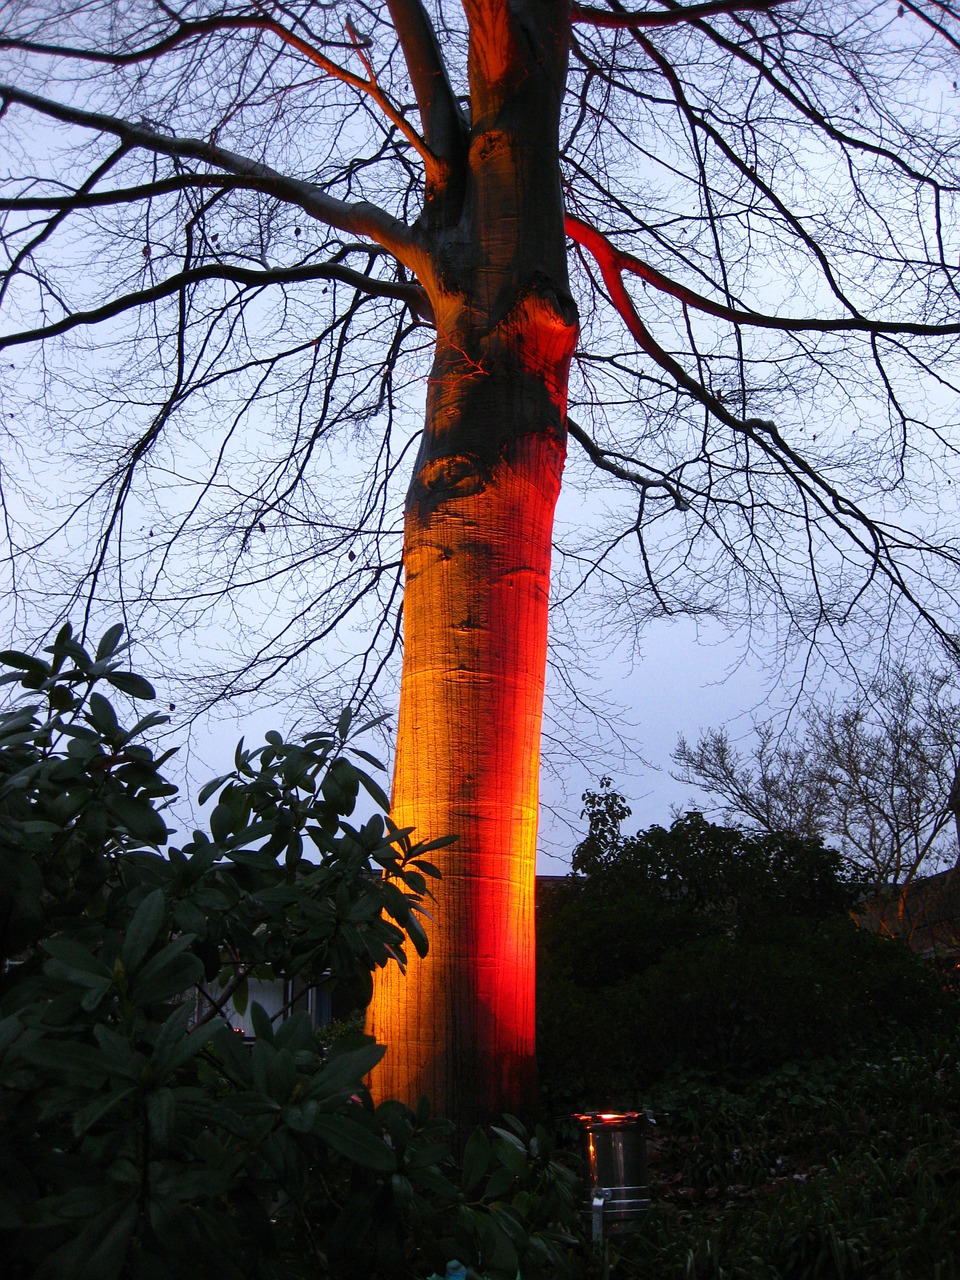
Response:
[369, 294, 576, 1132]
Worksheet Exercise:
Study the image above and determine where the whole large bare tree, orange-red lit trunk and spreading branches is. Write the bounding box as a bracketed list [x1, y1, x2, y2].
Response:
[0, 0, 960, 1120]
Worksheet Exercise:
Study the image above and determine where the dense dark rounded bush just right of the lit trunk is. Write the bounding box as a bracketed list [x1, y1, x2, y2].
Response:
[538, 780, 954, 1108]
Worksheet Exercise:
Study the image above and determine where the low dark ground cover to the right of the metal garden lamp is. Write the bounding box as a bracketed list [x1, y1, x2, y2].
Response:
[576, 1029, 960, 1280]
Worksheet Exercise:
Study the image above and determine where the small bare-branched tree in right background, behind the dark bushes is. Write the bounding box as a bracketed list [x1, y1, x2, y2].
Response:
[673, 669, 960, 888]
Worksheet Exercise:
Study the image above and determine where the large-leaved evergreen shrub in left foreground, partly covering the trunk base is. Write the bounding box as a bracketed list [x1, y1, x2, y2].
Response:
[0, 626, 586, 1280]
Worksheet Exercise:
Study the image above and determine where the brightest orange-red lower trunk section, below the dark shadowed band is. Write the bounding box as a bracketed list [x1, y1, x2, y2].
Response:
[363, 435, 562, 1115]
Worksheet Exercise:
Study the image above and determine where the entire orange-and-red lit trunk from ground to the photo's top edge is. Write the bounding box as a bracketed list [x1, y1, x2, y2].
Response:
[369, 0, 577, 1133]
